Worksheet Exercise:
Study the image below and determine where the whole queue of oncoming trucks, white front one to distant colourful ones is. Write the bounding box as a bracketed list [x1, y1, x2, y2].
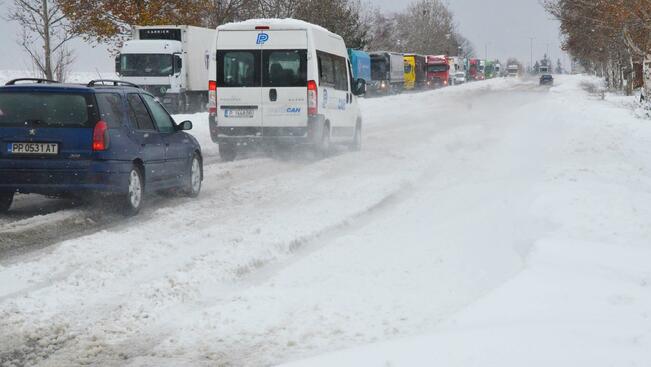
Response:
[115, 25, 499, 113]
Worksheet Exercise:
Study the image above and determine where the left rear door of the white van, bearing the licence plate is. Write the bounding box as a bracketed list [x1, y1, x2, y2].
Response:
[217, 30, 262, 136]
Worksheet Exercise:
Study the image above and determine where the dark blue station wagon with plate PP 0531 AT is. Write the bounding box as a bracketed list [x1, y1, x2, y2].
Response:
[0, 79, 203, 215]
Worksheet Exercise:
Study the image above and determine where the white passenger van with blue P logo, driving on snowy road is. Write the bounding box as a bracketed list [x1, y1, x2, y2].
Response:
[209, 19, 366, 161]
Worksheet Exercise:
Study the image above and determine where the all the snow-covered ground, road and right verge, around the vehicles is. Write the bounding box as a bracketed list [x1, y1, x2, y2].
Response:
[0, 76, 651, 367]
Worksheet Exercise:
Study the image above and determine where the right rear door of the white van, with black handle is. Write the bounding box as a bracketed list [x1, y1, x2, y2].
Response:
[262, 30, 307, 132]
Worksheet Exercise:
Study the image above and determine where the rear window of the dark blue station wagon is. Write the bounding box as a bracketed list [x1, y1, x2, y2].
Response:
[0, 91, 97, 127]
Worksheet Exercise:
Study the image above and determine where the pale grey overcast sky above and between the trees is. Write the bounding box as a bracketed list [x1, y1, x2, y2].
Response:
[0, 0, 568, 71]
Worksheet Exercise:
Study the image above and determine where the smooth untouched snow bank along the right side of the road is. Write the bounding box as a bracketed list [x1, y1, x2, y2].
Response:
[283, 77, 651, 367]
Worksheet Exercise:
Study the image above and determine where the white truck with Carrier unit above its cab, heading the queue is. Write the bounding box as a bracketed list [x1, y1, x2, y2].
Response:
[115, 25, 215, 113]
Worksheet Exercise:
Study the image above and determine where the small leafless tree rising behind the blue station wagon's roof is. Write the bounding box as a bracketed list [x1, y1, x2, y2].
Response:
[7, 0, 77, 79]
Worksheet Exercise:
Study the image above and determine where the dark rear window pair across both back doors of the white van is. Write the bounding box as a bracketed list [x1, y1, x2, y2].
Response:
[217, 50, 307, 88]
